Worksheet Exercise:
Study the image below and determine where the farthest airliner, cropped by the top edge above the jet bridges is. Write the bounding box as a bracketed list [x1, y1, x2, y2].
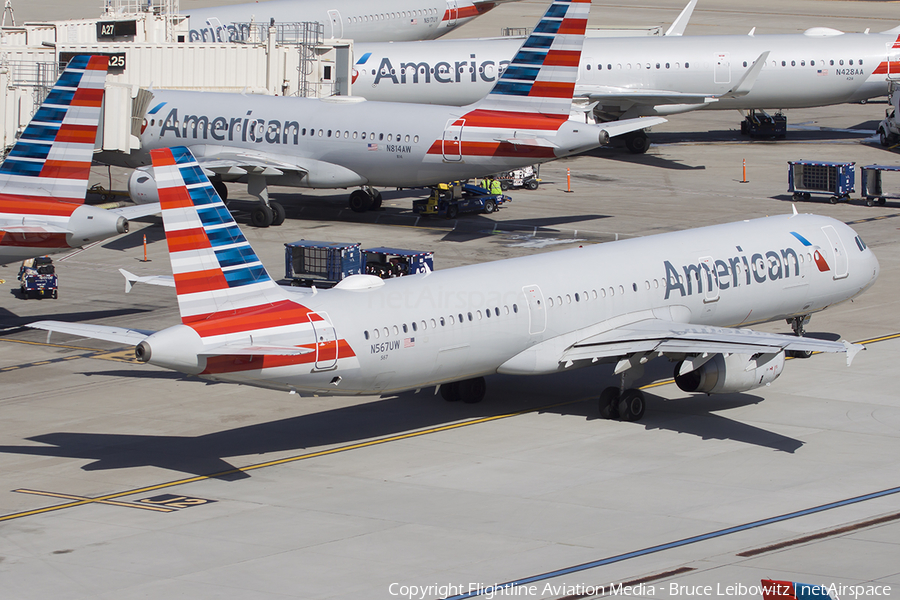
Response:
[184, 0, 516, 43]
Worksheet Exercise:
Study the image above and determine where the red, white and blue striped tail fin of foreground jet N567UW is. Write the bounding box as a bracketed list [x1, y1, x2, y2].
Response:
[150, 147, 292, 326]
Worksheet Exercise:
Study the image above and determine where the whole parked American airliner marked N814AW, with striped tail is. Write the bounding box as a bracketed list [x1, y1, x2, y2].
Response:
[116, 0, 664, 226]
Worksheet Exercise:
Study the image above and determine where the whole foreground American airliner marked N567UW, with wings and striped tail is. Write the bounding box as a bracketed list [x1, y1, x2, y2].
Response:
[30, 148, 879, 421]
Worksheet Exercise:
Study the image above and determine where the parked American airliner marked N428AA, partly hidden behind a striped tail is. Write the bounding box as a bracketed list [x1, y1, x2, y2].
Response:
[352, 21, 900, 152]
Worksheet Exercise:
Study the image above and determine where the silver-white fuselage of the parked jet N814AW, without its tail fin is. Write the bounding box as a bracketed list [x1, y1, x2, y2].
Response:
[125, 90, 616, 188]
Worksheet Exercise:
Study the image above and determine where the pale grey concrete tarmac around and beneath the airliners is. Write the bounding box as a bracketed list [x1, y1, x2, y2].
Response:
[0, 1, 900, 600]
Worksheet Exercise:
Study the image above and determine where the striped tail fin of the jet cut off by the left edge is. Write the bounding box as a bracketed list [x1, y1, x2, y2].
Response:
[0, 55, 109, 204]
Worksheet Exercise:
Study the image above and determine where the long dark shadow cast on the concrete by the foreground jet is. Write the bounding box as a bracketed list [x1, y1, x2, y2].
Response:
[0, 369, 803, 480]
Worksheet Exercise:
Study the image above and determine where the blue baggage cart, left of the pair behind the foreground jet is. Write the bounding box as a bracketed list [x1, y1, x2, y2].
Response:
[284, 240, 363, 288]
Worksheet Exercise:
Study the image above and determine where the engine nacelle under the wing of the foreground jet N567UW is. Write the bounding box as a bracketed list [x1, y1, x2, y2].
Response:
[675, 352, 784, 394]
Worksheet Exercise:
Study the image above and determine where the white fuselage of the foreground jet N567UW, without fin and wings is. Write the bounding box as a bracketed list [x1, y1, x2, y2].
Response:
[146, 215, 878, 395]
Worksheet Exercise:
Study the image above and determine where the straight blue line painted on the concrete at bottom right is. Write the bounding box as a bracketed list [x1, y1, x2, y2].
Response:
[444, 487, 900, 600]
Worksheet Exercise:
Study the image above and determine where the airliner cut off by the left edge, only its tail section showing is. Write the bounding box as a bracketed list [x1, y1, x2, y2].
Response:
[0, 56, 159, 264]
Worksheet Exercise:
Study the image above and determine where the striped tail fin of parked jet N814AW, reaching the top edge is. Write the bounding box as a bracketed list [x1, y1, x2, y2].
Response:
[474, 0, 591, 118]
